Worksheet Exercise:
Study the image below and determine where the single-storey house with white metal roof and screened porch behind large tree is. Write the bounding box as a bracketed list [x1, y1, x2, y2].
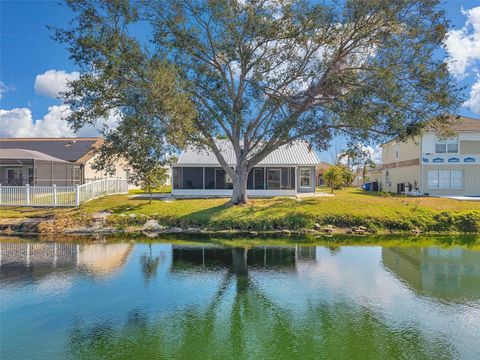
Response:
[172, 140, 321, 197]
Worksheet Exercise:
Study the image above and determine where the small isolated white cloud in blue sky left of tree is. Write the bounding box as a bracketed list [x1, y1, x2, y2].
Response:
[34, 70, 80, 99]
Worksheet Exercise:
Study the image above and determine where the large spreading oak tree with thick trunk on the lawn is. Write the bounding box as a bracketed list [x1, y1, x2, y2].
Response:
[57, 0, 460, 204]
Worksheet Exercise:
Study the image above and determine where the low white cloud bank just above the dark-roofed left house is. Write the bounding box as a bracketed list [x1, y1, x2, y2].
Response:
[0, 105, 118, 137]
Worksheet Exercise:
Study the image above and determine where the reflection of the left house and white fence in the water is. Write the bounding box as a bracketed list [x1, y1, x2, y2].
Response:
[0, 242, 133, 283]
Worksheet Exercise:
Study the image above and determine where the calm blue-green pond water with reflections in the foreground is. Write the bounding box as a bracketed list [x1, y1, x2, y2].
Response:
[0, 239, 480, 360]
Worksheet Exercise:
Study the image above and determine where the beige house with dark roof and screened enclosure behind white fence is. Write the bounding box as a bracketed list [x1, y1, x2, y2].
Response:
[0, 138, 127, 186]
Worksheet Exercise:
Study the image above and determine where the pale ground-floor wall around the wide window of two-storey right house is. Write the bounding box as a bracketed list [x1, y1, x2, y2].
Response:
[423, 165, 480, 196]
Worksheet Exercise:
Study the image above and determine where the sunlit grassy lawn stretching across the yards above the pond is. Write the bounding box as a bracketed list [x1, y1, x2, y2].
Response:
[0, 189, 480, 231]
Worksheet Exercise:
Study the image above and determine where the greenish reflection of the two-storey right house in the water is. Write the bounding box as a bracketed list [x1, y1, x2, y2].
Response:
[382, 248, 480, 301]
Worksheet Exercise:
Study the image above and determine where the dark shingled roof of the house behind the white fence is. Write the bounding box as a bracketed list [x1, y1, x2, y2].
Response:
[0, 138, 102, 162]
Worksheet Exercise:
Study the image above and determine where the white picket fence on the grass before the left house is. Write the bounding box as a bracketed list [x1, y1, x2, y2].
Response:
[0, 179, 128, 207]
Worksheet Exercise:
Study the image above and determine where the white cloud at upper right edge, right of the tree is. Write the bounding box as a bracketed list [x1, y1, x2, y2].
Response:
[445, 6, 480, 79]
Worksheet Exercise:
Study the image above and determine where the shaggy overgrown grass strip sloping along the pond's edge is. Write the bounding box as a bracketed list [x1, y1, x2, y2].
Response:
[107, 211, 480, 233]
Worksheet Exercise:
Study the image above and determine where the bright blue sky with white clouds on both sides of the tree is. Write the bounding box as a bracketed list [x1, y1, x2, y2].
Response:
[0, 0, 480, 161]
